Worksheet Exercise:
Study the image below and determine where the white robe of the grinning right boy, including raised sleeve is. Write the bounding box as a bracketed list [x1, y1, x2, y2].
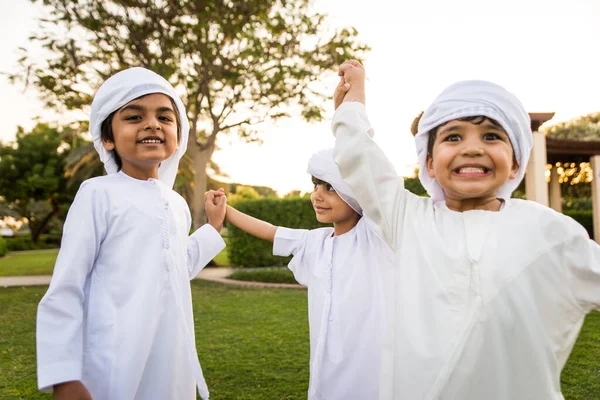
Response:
[333, 103, 600, 400]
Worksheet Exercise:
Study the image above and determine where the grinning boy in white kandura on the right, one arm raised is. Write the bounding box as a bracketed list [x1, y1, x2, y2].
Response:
[332, 61, 600, 400]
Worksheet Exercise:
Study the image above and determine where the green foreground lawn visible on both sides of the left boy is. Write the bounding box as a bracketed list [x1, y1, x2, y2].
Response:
[0, 281, 309, 400]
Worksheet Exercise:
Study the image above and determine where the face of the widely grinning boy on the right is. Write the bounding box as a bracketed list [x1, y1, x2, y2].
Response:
[427, 119, 518, 201]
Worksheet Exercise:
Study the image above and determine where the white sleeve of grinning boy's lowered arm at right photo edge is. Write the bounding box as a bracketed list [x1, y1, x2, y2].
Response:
[565, 225, 600, 313]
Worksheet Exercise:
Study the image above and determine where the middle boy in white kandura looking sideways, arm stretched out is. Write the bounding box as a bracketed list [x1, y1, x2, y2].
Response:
[209, 149, 392, 400]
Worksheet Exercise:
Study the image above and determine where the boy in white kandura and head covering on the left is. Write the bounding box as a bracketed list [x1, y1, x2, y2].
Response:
[37, 68, 225, 400]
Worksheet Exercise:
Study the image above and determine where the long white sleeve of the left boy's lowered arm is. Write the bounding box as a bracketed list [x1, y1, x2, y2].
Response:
[36, 182, 108, 390]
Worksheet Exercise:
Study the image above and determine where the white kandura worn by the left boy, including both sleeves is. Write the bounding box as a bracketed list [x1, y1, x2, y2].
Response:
[36, 172, 225, 400]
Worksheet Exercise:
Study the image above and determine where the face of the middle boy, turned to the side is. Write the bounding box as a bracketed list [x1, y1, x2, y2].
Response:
[310, 181, 357, 224]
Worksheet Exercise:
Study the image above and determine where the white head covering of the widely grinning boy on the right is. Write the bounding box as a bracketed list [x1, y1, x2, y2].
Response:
[415, 81, 533, 201]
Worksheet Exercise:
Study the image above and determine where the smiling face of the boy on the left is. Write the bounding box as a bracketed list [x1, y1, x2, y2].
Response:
[103, 93, 178, 176]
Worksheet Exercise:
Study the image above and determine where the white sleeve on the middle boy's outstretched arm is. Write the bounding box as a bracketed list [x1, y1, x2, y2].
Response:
[273, 226, 310, 286]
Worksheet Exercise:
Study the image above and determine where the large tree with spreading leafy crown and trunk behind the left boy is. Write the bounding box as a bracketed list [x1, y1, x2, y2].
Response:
[11, 0, 368, 226]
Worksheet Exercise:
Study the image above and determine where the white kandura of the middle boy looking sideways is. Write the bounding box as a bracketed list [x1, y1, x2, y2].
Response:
[273, 217, 392, 400]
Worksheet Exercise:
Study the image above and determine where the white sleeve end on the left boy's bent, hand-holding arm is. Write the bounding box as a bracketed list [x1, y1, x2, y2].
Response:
[188, 224, 225, 279]
